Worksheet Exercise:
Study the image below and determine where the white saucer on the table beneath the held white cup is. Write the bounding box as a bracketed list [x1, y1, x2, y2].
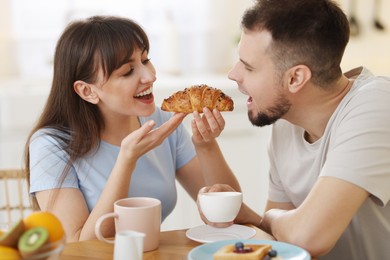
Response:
[186, 224, 256, 243]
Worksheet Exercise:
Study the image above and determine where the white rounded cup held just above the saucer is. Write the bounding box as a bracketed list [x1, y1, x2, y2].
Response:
[198, 191, 242, 223]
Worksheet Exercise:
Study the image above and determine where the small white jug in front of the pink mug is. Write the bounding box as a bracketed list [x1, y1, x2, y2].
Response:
[114, 230, 145, 260]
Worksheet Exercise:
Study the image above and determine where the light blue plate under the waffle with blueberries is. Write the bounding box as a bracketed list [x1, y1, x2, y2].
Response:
[188, 239, 311, 260]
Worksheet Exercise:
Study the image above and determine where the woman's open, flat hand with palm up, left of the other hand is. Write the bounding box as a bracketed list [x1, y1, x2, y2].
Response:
[121, 113, 186, 161]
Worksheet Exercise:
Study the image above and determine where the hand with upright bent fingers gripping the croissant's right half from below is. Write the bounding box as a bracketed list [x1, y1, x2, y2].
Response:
[191, 108, 225, 145]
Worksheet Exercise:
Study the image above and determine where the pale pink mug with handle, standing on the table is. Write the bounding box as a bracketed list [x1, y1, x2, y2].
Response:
[95, 197, 161, 252]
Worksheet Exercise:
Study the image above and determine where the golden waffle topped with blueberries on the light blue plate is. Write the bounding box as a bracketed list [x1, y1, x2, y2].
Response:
[213, 242, 272, 260]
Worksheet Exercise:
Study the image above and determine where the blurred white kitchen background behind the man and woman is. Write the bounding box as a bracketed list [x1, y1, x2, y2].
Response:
[0, 0, 390, 229]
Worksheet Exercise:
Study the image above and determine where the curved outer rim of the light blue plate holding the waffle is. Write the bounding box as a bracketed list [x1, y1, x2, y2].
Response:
[187, 238, 311, 260]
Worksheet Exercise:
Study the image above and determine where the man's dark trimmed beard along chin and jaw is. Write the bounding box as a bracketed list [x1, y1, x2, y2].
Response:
[248, 94, 291, 127]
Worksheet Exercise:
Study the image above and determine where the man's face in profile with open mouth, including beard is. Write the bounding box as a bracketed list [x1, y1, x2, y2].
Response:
[229, 30, 291, 126]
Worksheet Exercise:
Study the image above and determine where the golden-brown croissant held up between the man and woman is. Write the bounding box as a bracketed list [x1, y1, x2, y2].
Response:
[161, 84, 234, 114]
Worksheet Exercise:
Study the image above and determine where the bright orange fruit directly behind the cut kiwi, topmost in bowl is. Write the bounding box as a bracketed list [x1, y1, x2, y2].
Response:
[24, 211, 65, 242]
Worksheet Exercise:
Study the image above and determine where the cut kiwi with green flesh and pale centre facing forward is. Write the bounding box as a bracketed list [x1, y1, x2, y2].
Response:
[18, 227, 49, 256]
